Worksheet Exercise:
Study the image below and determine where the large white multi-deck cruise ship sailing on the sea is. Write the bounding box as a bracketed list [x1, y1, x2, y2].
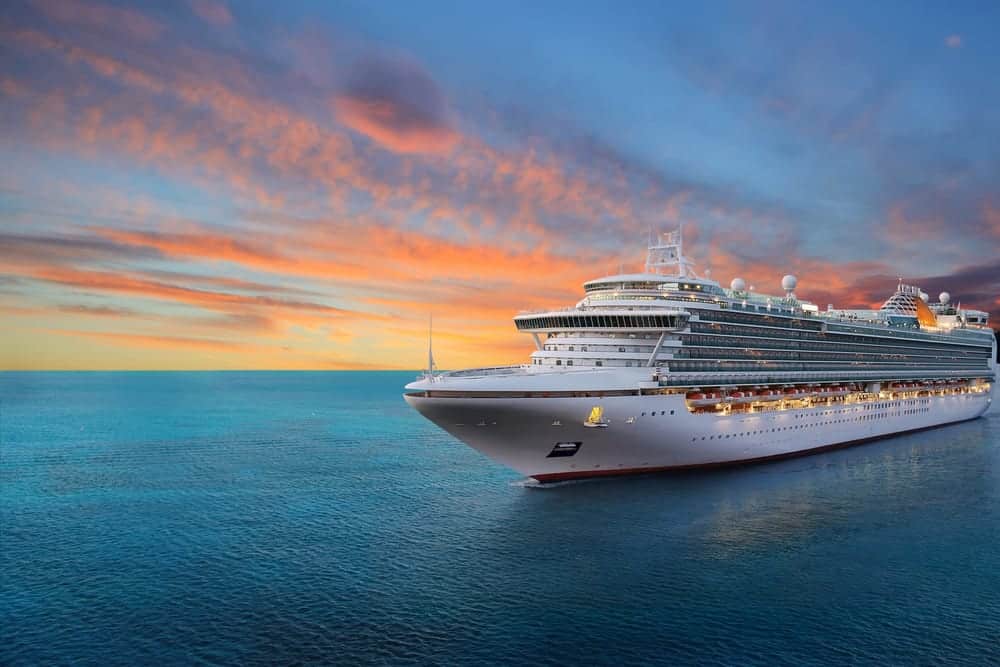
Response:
[404, 230, 997, 483]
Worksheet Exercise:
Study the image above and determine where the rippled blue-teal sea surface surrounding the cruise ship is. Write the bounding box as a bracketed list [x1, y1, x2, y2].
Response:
[0, 373, 1000, 665]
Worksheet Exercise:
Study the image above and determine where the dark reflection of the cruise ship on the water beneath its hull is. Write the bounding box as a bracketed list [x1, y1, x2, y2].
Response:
[494, 415, 1000, 558]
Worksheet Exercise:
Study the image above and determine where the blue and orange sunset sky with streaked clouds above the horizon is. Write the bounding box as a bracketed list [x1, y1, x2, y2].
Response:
[0, 0, 1000, 370]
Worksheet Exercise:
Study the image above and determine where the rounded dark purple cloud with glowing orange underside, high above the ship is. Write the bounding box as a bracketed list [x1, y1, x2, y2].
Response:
[334, 58, 459, 154]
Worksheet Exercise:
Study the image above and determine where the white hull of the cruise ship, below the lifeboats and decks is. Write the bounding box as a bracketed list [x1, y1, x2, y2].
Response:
[406, 383, 991, 482]
